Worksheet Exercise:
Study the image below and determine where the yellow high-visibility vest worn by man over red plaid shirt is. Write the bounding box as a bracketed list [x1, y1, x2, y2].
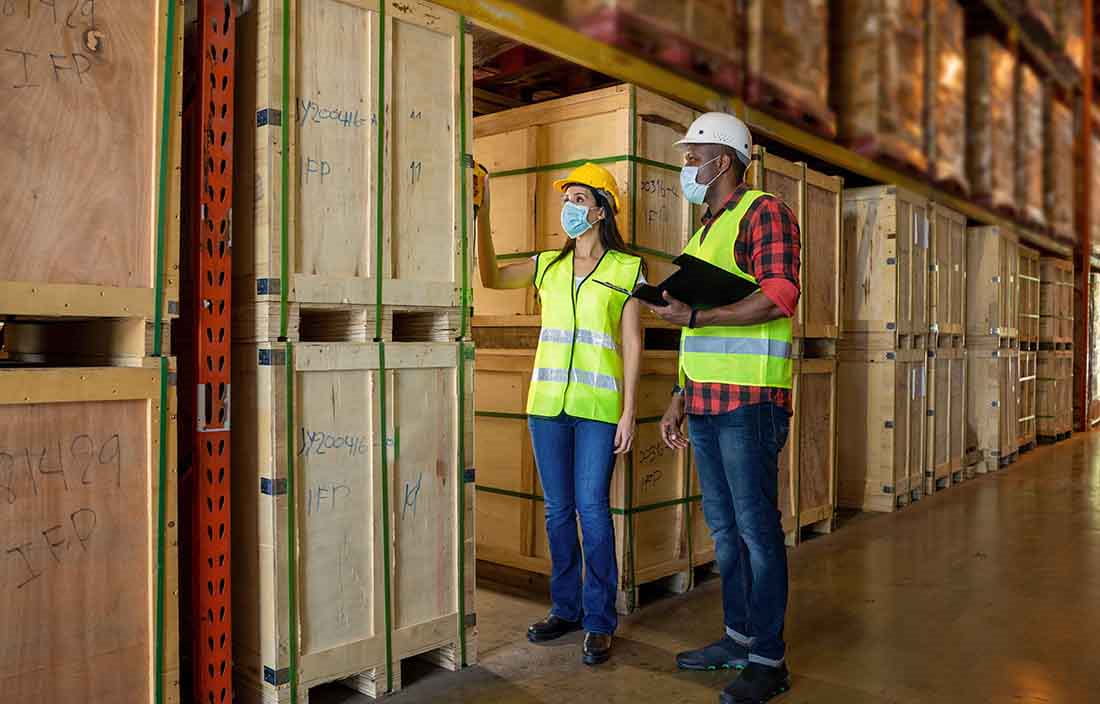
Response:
[680, 190, 792, 388]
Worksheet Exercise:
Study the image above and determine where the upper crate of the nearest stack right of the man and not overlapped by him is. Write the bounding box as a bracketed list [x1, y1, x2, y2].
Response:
[840, 186, 928, 349]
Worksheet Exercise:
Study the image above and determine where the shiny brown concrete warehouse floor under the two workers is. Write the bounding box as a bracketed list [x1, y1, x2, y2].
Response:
[310, 433, 1100, 704]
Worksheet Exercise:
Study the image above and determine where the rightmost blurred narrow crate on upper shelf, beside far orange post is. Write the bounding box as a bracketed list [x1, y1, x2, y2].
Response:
[1047, 92, 1077, 242]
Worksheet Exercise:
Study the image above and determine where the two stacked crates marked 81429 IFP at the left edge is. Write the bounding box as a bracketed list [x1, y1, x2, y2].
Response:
[0, 0, 183, 704]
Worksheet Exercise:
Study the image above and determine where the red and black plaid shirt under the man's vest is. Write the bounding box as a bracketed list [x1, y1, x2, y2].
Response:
[684, 185, 802, 416]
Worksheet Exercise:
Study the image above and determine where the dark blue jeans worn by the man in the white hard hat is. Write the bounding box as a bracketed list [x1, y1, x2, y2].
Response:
[688, 404, 790, 667]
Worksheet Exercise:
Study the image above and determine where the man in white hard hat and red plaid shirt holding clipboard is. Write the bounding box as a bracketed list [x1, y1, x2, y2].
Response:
[650, 112, 801, 704]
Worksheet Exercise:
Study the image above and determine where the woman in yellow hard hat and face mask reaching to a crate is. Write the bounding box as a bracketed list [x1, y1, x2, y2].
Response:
[477, 164, 644, 666]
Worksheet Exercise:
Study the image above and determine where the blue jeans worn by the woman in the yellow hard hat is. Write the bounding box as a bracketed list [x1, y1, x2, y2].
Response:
[527, 414, 618, 635]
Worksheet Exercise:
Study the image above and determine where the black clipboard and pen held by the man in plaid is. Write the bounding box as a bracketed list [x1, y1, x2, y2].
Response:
[593, 254, 760, 309]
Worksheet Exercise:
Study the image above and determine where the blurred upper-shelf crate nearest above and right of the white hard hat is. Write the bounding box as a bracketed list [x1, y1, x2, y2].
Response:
[727, 0, 836, 138]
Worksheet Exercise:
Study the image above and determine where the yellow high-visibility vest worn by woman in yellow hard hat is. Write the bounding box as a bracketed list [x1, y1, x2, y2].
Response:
[527, 251, 641, 424]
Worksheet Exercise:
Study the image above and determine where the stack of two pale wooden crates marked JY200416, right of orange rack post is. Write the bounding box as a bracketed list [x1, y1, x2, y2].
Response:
[232, 0, 476, 702]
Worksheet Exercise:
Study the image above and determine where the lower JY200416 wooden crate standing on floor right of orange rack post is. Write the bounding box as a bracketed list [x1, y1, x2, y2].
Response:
[231, 343, 476, 703]
